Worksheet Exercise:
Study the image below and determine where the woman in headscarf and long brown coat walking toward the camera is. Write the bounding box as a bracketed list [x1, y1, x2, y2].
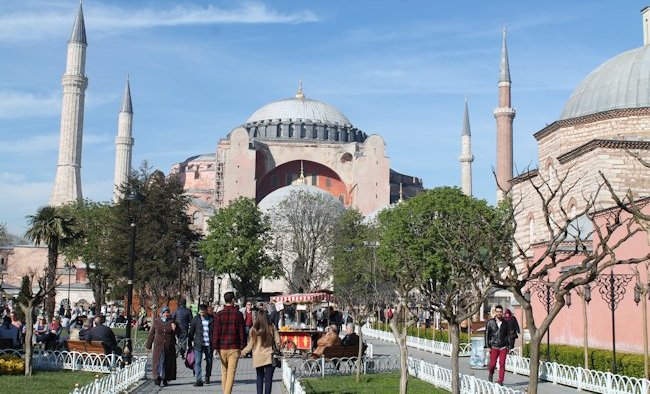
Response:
[145, 306, 178, 386]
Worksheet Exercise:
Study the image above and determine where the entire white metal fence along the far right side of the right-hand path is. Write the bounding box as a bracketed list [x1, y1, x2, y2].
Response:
[363, 325, 650, 394]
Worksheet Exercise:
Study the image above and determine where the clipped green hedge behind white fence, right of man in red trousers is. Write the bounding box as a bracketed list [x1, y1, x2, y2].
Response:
[524, 343, 643, 378]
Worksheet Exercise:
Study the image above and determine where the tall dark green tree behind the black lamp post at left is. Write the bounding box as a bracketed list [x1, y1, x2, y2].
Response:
[106, 162, 199, 306]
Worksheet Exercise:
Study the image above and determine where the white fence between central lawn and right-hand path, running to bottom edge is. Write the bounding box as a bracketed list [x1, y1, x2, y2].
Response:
[408, 357, 518, 394]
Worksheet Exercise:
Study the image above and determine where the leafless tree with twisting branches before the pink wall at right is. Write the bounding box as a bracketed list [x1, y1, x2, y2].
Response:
[483, 171, 650, 394]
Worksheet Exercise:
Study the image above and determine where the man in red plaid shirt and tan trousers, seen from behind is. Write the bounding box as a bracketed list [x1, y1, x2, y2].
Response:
[212, 291, 246, 394]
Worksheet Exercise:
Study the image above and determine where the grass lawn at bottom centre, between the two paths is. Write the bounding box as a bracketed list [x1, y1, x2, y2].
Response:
[300, 372, 448, 394]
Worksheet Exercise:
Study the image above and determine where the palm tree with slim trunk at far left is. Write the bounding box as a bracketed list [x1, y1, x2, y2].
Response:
[25, 206, 74, 320]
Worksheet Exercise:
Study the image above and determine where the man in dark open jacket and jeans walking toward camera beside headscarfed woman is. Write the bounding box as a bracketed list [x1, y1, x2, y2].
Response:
[188, 304, 214, 387]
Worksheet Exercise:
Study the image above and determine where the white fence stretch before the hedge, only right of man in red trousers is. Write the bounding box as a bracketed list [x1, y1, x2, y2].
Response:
[506, 354, 650, 394]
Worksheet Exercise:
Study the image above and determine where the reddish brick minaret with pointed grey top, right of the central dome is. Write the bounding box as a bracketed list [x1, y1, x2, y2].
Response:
[494, 28, 515, 202]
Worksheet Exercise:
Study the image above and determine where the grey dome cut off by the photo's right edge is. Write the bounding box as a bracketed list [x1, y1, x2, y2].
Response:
[560, 46, 650, 119]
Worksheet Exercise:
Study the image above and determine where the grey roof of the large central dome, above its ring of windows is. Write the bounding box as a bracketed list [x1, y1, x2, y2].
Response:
[246, 86, 351, 125]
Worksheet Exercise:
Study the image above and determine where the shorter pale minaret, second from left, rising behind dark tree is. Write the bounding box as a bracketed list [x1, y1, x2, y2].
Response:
[113, 77, 133, 203]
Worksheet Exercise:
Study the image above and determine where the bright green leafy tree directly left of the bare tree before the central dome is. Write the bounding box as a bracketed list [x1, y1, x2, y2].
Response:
[200, 197, 281, 297]
